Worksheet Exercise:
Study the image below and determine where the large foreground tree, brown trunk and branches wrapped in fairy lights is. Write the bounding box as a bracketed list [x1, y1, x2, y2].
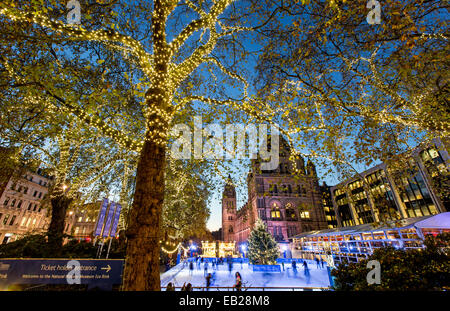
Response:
[0, 0, 290, 290]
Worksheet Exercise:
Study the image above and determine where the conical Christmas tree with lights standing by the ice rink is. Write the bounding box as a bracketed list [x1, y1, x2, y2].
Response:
[248, 219, 279, 265]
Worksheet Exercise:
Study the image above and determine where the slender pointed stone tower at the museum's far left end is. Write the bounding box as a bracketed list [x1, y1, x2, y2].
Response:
[222, 175, 236, 242]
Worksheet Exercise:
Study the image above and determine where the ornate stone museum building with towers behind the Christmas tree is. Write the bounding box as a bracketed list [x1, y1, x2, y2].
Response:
[222, 137, 328, 251]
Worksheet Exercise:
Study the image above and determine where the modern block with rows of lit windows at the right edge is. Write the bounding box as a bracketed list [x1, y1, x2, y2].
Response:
[330, 139, 450, 227]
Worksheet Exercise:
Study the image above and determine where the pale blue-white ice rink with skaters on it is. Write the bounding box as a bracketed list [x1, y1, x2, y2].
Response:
[161, 260, 330, 291]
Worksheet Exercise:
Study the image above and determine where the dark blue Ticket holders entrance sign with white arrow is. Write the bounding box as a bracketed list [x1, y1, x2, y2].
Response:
[0, 259, 124, 285]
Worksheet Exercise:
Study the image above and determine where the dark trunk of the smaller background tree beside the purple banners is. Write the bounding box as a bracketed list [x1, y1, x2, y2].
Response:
[47, 194, 72, 256]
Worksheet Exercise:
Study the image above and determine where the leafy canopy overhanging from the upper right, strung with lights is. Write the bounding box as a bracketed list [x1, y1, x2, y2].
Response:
[256, 0, 450, 182]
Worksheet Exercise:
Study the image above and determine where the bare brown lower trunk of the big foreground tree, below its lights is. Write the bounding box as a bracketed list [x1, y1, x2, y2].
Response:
[122, 132, 166, 291]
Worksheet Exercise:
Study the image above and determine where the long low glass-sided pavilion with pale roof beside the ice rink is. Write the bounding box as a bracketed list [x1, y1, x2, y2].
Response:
[292, 212, 450, 266]
